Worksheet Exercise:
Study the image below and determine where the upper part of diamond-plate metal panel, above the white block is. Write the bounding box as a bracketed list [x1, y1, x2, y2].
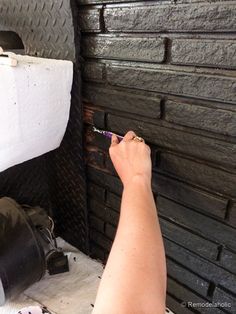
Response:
[0, 0, 75, 61]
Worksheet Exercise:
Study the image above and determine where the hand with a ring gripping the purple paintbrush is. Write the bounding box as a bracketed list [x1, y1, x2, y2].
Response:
[109, 131, 152, 186]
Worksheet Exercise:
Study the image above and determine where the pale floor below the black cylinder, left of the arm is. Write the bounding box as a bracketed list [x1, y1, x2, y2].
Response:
[0, 239, 172, 314]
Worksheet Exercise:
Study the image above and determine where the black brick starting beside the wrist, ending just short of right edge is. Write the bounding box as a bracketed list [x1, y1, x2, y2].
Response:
[152, 173, 228, 218]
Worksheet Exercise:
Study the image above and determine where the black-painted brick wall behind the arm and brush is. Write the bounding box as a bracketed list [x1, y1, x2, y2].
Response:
[77, 0, 236, 314]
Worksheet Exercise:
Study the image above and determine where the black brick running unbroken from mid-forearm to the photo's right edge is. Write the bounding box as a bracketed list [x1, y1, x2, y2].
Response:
[157, 197, 236, 251]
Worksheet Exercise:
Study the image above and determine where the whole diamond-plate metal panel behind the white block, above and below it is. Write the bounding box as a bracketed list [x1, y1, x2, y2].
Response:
[0, 0, 88, 252]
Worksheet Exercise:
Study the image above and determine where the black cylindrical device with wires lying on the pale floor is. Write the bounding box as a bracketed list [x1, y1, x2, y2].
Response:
[0, 197, 69, 305]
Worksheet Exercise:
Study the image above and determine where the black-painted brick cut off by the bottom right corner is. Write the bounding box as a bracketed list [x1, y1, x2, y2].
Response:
[213, 287, 236, 314]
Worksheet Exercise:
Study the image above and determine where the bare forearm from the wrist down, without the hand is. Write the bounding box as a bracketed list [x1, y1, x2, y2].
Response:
[93, 176, 166, 314]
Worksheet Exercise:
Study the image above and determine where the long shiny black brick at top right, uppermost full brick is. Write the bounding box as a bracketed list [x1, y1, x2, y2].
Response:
[104, 1, 236, 32]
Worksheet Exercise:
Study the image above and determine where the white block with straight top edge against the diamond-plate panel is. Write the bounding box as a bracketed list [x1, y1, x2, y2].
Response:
[0, 55, 73, 171]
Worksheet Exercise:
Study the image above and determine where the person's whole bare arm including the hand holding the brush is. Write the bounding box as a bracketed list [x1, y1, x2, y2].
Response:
[93, 132, 166, 314]
